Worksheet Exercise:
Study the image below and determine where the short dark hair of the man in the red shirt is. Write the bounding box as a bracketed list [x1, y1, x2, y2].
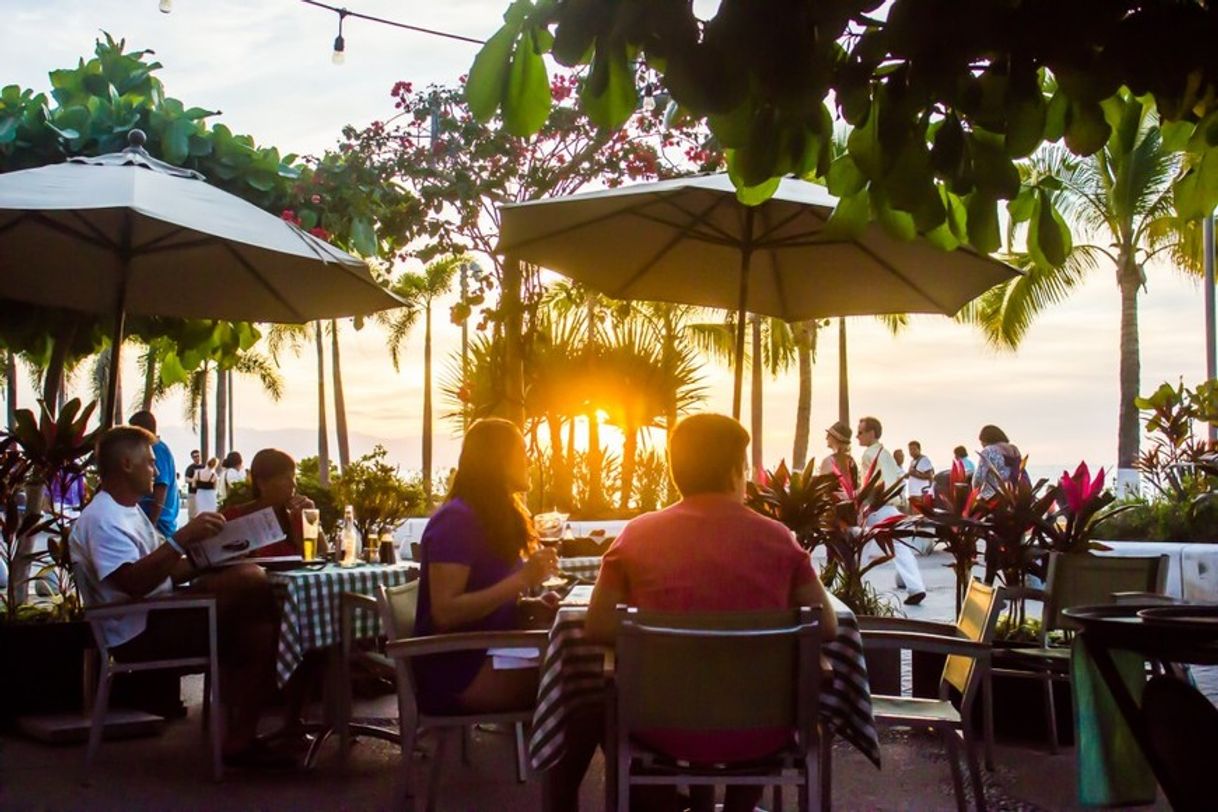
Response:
[669, 414, 749, 497]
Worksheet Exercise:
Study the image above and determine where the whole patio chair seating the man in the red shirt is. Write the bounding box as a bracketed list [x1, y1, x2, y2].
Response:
[605, 606, 823, 811]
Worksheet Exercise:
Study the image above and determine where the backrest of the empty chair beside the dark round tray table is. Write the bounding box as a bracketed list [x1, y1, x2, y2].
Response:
[1041, 553, 1168, 637]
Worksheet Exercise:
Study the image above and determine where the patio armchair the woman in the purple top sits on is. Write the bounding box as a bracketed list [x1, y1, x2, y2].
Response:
[340, 581, 548, 812]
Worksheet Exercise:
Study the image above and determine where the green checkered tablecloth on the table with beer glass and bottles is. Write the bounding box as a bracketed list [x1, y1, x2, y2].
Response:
[267, 562, 419, 687]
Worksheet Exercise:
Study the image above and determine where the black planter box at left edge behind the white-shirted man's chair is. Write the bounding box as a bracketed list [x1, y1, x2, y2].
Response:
[0, 621, 93, 728]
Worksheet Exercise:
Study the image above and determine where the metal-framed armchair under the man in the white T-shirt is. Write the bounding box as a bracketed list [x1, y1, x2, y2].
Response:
[77, 594, 224, 783]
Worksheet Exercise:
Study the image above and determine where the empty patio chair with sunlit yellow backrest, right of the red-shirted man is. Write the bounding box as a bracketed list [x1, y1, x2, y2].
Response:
[859, 581, 1002, 811]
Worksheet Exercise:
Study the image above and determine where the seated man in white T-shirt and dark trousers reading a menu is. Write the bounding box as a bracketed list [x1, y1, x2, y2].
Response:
[69, 426, 291, 767]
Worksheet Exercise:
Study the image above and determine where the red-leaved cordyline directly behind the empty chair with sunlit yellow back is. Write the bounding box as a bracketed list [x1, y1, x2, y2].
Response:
[910, 460, 988, 615]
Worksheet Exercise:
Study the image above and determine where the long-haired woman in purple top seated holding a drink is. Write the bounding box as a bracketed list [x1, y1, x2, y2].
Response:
[414, 419, 558, 713]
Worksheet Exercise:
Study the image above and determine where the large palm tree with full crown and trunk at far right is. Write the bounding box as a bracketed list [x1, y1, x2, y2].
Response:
[961, 93, 1200, 469]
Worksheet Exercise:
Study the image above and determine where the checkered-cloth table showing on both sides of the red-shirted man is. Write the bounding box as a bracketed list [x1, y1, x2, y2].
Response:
[529, 594, 881, 772]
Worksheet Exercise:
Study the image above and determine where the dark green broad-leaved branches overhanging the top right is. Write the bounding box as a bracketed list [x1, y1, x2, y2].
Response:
[468, 0, 1218, 265]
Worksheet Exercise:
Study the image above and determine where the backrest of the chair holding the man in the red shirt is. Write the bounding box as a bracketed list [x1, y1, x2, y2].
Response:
[616, 606, 821, 747]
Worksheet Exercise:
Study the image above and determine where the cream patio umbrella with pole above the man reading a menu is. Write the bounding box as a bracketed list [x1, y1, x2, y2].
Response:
[0, 130, 403, 425]
